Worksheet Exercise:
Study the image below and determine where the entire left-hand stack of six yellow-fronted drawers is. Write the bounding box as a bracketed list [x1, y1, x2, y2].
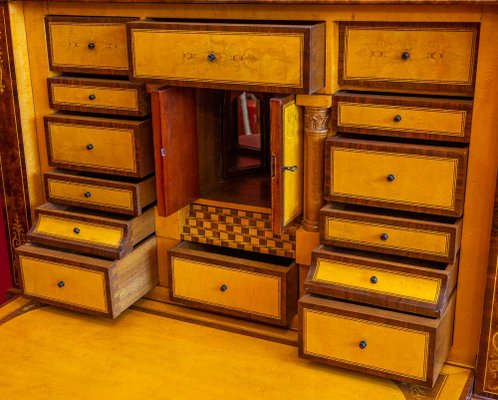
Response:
[14, 16, 157, 318]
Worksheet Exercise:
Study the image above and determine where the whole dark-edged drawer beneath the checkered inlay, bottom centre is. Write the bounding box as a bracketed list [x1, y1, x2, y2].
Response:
[168, 242, 298, 326]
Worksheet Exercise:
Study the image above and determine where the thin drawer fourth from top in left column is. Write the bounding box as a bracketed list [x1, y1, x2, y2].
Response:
[44, 170, 156, 216]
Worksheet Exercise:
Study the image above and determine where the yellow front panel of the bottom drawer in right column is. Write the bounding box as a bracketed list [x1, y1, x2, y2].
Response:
[302, 308, 430, 381]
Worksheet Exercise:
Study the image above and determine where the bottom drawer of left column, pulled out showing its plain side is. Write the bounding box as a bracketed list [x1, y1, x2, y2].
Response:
[16, 237, 157, 318]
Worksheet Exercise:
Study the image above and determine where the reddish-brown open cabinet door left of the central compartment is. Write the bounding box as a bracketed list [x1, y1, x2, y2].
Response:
[152, 87, 199, 217]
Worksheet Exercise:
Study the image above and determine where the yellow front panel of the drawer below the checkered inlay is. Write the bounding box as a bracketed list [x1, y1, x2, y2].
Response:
[171, 257, 282, 319]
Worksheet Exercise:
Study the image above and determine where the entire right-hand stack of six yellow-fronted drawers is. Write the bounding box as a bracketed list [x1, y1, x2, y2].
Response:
[299, 22, 479, 386]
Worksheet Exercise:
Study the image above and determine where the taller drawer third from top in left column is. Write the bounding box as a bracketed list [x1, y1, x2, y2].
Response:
[45, 113, 154, 178]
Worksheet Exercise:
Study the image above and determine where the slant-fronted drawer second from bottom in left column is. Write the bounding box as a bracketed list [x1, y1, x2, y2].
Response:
[28, 203, 154, 259]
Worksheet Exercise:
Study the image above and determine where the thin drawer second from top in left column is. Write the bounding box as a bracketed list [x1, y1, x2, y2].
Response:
[47, 76, 150, 117]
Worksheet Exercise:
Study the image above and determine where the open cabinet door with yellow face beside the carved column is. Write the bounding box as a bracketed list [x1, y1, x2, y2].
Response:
[270, 96, 304, 233]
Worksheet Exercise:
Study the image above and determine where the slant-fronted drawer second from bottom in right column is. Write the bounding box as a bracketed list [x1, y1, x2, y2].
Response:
[304, 245, 458, 318]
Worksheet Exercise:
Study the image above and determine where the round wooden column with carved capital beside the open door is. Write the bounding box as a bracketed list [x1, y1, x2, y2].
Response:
[303, 107, 330, 232]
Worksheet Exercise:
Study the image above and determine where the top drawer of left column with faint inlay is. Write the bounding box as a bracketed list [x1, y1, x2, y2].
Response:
[45, 15, 138, 75]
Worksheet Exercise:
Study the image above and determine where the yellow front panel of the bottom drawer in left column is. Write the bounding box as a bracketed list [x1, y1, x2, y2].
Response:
[19, 255, 108, 313]
